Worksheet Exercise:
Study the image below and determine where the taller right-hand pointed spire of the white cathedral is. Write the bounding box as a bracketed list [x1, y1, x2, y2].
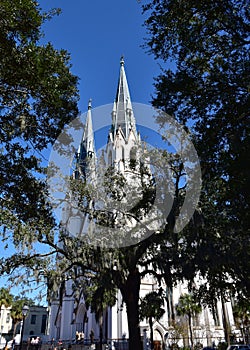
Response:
[112, 56, 136, 139]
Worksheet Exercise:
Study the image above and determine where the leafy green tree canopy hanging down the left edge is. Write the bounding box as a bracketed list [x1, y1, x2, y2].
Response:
[0, 0, 78, 284]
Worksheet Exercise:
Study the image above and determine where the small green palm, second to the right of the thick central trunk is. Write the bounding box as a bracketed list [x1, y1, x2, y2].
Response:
[176, 294, 201, 348]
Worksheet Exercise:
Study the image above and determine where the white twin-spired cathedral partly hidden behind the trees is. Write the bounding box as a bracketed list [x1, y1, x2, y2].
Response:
[49, 58, 237, 350]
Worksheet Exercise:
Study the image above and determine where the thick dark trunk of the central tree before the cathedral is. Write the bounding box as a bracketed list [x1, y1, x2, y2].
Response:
[121, 269, 142, 350]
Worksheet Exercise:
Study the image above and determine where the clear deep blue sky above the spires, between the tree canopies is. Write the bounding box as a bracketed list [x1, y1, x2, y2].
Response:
[40, 0, 160, 112]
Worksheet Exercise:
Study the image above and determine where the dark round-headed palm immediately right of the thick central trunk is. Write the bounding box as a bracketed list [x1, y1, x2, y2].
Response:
[140, 292, 165, 349]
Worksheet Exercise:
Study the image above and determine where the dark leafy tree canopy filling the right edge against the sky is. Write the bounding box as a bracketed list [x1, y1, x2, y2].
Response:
[143, 0, 250, 299]
